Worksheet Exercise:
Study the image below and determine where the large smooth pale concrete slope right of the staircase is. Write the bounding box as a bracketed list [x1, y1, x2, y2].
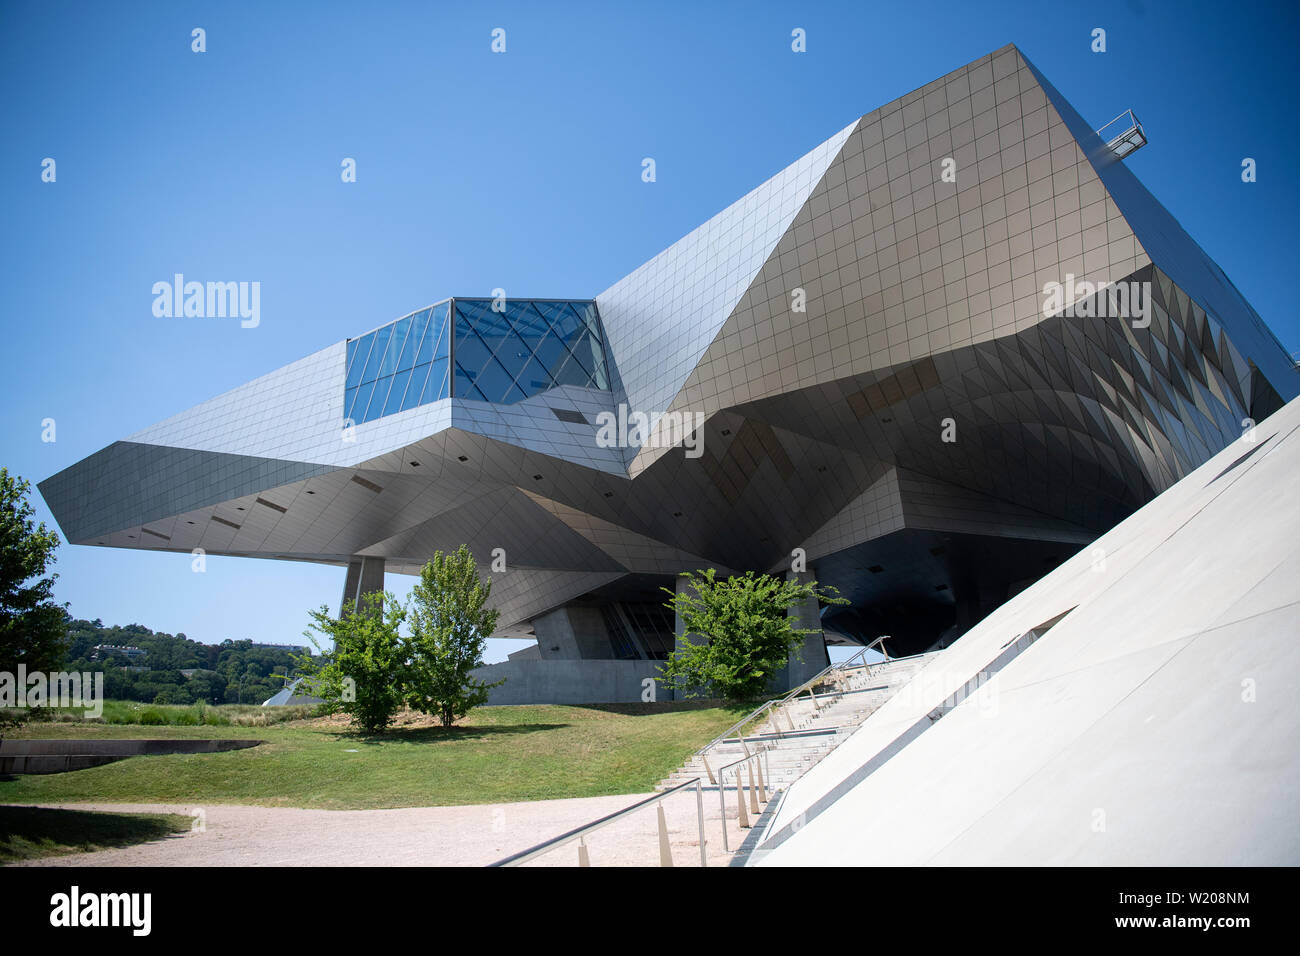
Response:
[751, 399, 1300, 866]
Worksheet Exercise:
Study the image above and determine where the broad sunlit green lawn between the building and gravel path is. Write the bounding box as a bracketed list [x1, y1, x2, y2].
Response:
[0, 704, 751, 809]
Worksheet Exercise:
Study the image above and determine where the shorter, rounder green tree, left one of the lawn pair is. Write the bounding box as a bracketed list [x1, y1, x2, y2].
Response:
[294, 592, 407, 734]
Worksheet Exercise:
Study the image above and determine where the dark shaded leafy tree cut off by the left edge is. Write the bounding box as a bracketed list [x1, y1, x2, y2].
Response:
[0, 467, 68, 674]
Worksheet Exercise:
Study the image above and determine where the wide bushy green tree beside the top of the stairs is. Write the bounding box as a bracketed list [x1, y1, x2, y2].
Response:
[659, 568, 848, 700]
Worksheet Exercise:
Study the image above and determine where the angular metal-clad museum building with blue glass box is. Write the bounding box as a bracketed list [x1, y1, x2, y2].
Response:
[40, 46, 1297, 693]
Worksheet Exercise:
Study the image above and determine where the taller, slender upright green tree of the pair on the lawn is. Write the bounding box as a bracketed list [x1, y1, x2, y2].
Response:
[406, 545, 503, 727]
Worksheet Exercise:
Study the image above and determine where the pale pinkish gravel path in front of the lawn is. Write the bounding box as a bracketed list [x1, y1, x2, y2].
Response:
[7, 792, 748, 866]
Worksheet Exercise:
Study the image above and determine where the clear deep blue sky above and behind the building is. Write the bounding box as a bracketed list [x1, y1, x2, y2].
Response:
[0, 0, 1300, 659]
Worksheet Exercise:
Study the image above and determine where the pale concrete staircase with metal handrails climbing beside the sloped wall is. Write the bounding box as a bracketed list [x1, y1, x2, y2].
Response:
[655, 652, 941, 792]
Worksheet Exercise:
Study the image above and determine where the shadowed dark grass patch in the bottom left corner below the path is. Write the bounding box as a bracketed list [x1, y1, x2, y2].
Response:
[0, 806, 192, 866]
